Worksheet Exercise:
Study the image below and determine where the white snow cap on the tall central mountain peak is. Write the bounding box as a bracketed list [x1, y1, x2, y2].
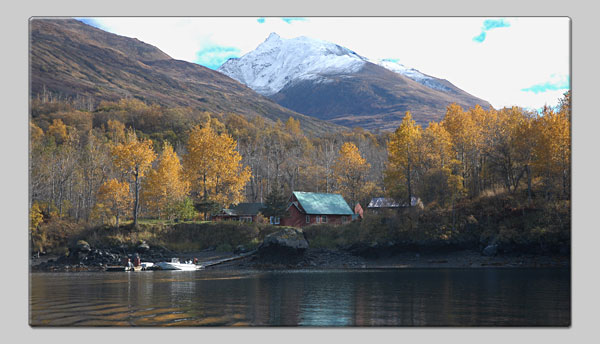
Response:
[217, 33, 368, 96]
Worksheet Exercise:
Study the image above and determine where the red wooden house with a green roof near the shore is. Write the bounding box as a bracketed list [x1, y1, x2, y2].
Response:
[281, 191, 354, 227]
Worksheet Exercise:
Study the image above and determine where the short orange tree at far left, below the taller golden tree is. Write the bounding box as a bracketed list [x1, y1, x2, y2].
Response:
[94, 178, 131, 228]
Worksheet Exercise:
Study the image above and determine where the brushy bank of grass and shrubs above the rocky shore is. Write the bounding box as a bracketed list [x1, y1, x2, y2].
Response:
[33, 187, 571, 254]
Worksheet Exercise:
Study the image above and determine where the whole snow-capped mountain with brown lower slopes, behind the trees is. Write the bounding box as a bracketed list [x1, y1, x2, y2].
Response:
[218, 33, 490, 130]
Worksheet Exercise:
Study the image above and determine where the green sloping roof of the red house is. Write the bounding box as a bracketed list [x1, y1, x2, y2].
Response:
[294, 191, 354, 215]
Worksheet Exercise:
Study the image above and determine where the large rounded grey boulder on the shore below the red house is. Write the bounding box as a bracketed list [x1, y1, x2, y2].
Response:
[258, 228, 308, 262]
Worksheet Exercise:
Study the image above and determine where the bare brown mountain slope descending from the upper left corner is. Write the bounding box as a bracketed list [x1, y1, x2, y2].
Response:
[29, 18, 343, 134]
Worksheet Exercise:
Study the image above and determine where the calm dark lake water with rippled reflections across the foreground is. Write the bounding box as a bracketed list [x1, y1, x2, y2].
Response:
[29, 268, 571, 326]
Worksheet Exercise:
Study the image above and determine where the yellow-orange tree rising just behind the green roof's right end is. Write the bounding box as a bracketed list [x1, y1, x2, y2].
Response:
[333, 142, 371, 207]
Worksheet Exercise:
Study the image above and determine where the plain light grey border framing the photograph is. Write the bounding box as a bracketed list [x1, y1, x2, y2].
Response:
[0, 0, 600, 344]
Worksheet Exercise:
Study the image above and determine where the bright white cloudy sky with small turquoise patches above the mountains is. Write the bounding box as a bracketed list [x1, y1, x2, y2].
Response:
[74, 17, 570, 108]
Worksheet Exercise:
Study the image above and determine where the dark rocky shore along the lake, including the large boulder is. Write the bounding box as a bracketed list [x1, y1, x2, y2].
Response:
[30, 228, 570, 272]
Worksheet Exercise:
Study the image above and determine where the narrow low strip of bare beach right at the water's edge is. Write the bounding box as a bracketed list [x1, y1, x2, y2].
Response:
[29, 249, 571, 273]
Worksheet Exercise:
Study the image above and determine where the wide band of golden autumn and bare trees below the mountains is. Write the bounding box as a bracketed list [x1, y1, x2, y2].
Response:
[29, 92, 571, 234]
